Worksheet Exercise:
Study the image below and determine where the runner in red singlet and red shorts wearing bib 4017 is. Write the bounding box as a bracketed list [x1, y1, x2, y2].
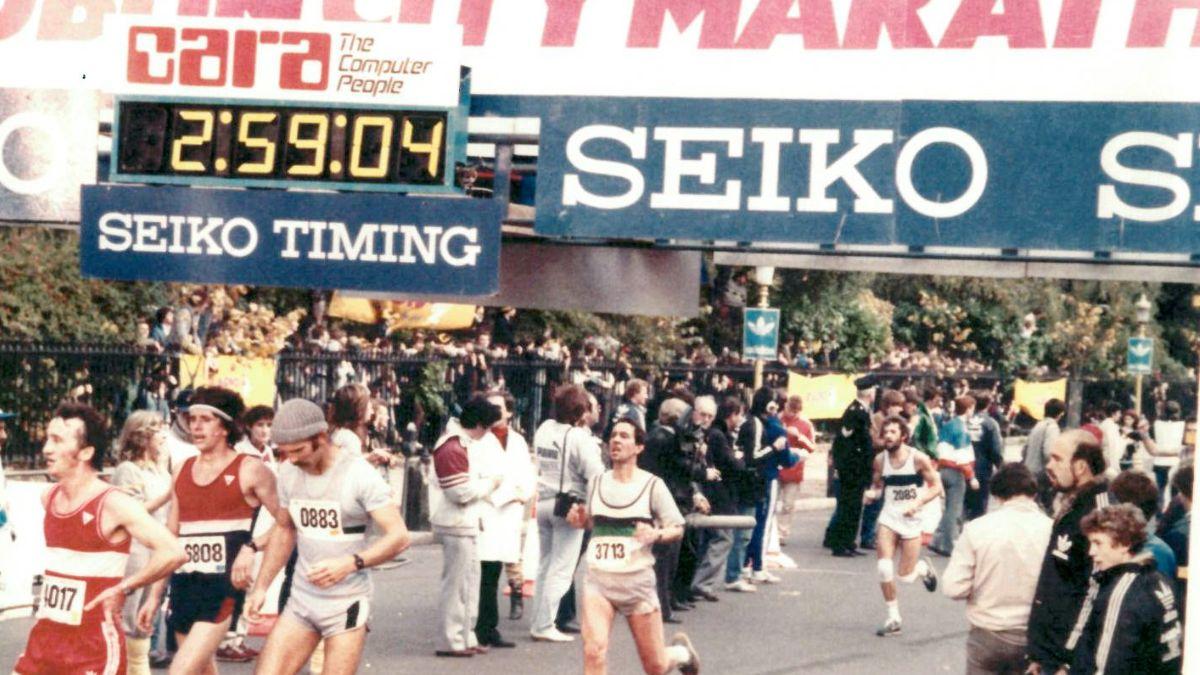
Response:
[14, 404, 184, 675]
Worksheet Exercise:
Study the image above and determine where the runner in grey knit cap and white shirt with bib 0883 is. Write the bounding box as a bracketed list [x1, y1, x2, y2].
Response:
[246, 399, 409, 675]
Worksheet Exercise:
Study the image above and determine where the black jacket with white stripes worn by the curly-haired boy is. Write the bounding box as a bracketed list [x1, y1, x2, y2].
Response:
[1067, 554, 1183, 675]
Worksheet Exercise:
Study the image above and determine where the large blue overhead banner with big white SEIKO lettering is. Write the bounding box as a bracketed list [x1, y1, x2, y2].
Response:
[536, 98, 1200, 255]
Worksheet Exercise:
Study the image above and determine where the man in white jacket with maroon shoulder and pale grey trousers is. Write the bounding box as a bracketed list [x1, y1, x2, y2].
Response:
[430, 395, 503, 657]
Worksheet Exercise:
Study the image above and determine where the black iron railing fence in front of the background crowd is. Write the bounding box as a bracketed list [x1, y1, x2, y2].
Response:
[0, 342, 1195, 468]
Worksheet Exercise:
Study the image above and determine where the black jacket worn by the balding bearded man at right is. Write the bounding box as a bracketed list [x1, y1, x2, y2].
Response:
[1028, 479, 1109, 673]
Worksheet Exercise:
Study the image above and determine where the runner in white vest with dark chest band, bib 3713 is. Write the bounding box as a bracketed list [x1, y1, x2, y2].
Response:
[566, 419, 700, 674]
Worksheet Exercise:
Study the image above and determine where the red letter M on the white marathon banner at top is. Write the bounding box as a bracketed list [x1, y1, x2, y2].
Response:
[625, 0, 740, 49]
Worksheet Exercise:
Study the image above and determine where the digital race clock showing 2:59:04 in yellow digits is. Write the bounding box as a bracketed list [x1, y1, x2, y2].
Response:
[109, 90, 466, 192]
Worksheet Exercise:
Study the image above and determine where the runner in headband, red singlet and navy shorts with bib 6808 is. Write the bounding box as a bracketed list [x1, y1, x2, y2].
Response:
[138, 387, 281, 675]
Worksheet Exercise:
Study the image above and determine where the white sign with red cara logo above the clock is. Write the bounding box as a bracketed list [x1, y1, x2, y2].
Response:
[107, 18, 462, 107]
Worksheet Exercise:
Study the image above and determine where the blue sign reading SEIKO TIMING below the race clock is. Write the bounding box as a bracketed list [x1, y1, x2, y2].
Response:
[80, 185, 500, 295]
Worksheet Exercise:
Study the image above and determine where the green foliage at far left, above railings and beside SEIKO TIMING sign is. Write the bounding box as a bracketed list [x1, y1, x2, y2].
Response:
[0, 227, 168, 342]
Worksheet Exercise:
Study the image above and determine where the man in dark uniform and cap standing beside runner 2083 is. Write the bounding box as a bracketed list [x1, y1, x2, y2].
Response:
[829, 375, 875, 557]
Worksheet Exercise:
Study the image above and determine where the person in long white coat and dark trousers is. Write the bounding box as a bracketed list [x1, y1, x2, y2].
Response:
[470, 393, 536, 649]
